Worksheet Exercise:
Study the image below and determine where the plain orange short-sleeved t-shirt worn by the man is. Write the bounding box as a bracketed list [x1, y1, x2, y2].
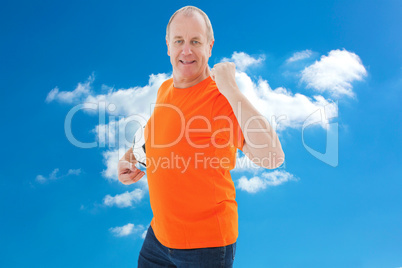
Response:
[144, 77, 244, 249]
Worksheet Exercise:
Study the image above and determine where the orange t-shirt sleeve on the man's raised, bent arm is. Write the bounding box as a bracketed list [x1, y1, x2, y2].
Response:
[212, 94, 244, 150]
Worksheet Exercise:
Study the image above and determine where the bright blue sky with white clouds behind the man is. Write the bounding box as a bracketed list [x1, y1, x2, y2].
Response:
[0, 0, 402, 267]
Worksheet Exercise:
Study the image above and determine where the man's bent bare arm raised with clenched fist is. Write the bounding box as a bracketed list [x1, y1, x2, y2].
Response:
[211, 62, 285, 169]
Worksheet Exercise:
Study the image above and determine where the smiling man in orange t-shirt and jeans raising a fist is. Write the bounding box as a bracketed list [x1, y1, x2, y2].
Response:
[118, 6, 284, 267]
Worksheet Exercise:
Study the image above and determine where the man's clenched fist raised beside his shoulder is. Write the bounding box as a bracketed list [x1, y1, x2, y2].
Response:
[211, 62, 240, 99]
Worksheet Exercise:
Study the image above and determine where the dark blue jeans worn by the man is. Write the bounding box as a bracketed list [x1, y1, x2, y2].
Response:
[138, 226, 236, 268]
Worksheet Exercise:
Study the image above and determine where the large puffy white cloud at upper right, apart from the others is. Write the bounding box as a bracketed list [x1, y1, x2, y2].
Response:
[301, 49, 367, 97]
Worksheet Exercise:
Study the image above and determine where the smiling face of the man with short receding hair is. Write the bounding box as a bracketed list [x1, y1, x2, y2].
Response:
[166, 12, 214, 82]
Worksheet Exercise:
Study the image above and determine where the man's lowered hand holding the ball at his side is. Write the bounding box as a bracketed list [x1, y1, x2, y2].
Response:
[117, 148, 145, 185]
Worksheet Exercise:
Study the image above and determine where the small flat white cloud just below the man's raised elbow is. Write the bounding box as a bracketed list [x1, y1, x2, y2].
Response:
[237, 170, 298, 194]
